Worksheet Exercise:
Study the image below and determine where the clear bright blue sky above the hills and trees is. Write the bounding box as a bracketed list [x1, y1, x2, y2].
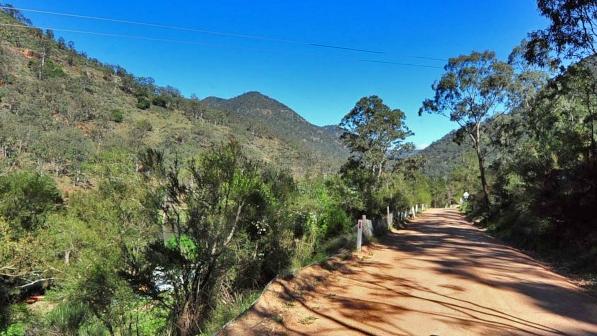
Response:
[7, 0, 545, 147]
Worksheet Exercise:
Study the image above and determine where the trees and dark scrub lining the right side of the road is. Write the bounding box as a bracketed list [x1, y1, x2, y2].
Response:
[421, 0, 597, 278]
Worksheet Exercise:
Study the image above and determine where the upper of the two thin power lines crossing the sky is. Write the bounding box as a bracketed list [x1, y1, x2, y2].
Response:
[0, 5, 385, 54]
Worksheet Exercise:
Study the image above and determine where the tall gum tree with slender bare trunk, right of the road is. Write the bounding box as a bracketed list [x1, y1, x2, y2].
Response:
[419, 51, 513, 208]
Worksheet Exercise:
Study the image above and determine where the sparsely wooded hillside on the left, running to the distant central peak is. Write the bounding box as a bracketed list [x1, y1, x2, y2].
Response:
[0, 12, 347, 186]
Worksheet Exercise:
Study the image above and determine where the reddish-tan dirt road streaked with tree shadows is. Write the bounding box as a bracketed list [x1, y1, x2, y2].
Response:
[222, 209, 597, 336]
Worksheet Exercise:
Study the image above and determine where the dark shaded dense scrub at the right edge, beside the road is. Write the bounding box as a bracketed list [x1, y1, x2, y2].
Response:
[490, 63, 597, 270]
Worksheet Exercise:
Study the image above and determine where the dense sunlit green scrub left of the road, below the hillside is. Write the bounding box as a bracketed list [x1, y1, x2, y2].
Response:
[0, 142, 430, 335]
